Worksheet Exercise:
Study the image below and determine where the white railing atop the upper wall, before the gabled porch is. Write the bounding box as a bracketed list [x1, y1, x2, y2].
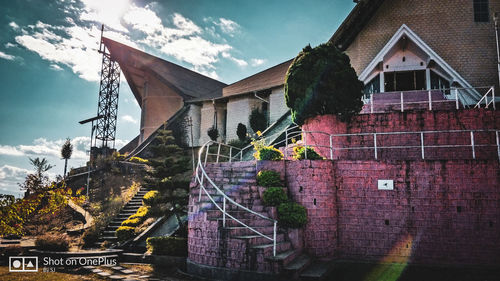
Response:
[363, 86, 495, 113]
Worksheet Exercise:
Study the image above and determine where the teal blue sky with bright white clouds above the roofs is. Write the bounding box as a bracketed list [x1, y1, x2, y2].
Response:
[0, 0, 355, 196]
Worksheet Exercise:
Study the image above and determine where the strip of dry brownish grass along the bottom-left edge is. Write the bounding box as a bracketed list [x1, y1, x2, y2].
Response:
[0, 266, 104, 281]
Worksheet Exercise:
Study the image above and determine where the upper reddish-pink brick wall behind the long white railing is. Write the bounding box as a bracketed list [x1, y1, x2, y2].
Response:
[302, 109, 500, 160]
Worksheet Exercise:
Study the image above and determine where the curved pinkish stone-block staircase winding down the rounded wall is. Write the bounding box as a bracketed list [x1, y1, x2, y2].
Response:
[189, 161, 311, 277]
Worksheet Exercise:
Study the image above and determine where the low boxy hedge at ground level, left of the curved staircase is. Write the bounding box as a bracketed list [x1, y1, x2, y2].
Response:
[146, 237, 187, 257]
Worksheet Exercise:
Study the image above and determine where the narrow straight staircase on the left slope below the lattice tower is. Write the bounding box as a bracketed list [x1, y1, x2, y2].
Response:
[97, 187, 149, 245]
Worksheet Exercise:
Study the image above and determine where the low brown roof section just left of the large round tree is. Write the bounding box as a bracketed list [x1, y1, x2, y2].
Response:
[222, 59, 293, 97]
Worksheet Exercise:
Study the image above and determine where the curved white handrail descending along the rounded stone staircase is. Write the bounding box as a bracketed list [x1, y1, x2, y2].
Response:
[195, 141, 277, 256]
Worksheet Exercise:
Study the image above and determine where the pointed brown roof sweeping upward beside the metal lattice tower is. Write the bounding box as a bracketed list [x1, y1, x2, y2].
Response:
[102, 37, 226, 105]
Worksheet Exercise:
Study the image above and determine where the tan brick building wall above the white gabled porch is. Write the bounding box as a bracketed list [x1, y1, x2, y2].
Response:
[346, 0, 500, 89]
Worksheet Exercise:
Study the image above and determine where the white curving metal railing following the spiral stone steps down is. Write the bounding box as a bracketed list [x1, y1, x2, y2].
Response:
[195, 141, 278, 256]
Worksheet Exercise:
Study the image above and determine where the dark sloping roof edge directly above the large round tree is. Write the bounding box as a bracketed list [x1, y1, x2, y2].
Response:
[330, 0, 384, 51]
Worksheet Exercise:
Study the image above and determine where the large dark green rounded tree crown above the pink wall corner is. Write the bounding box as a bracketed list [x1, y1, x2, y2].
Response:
[285, 42, 363, 125]
